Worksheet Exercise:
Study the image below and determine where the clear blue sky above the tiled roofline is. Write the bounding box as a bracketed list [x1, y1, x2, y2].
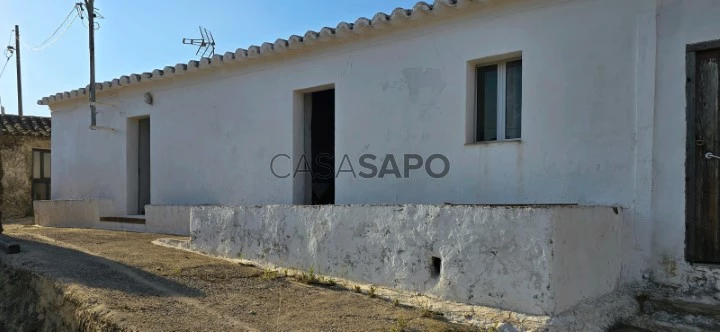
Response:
[0, 0, 416, 116]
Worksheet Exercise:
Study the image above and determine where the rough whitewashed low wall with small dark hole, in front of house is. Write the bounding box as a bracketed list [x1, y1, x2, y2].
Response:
[190, 205, 622, 315]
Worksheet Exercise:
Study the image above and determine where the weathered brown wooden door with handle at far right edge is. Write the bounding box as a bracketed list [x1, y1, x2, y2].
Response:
[686, 44, 720, 263]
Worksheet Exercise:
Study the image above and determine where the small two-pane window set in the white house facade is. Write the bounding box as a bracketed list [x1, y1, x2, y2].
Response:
[474, 59, 522, 142]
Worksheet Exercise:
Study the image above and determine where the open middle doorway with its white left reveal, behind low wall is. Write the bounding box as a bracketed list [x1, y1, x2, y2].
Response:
[295, 89, 335, 205]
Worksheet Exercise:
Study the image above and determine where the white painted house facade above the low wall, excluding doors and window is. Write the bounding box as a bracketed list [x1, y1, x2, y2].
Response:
[36, 0, 720, 316]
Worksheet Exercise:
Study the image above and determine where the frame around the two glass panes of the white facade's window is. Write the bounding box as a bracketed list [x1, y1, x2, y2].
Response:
[468, 55, 524, 144]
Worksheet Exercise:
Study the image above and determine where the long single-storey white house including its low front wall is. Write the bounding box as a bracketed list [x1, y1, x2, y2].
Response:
[35, 0, 720, 322]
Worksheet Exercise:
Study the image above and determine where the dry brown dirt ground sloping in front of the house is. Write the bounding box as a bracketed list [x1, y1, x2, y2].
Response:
[0, 224, 484, 331]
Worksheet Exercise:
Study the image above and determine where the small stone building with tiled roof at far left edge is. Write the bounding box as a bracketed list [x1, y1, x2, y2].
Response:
[0, 114, 51, 218]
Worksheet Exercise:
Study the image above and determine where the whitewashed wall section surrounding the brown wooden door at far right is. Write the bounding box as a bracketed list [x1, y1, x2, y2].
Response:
[652, 0, 720, 292]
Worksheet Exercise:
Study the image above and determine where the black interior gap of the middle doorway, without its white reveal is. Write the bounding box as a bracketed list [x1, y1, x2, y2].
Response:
[306, 89, 335, 205]
